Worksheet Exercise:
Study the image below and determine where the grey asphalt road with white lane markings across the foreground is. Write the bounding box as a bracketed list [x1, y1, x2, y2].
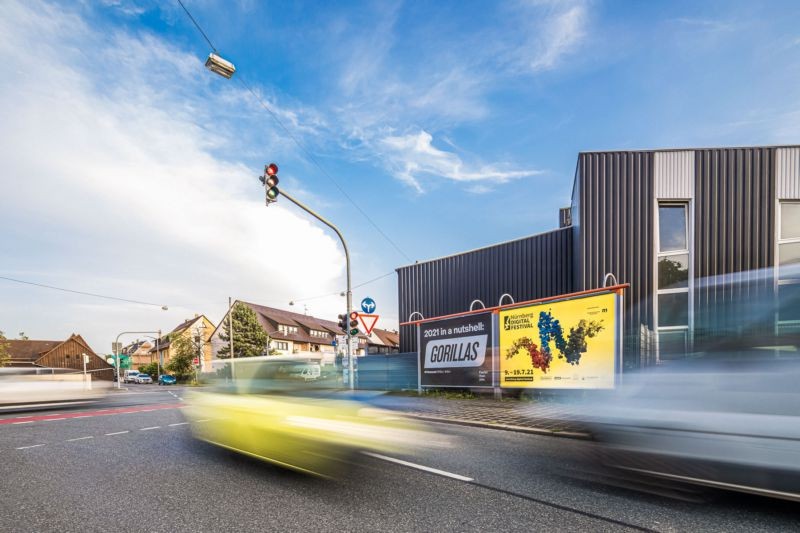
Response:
[0, 386, 800, 532]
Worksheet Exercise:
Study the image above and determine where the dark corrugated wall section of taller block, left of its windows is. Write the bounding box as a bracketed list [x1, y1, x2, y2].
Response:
[573, 152, 654, 368]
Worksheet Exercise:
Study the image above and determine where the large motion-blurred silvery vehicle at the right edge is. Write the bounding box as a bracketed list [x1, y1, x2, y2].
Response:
[587, 271, 800, 501]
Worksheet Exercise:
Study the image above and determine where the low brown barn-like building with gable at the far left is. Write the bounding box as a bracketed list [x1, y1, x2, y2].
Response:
[3, 333, 114, 381]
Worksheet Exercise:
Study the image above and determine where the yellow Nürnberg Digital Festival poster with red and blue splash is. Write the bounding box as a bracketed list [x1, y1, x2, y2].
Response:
[499, 293, 618, 389]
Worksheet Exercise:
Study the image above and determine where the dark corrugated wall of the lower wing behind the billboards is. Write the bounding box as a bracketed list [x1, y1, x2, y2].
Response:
[397, 228, 573, 352]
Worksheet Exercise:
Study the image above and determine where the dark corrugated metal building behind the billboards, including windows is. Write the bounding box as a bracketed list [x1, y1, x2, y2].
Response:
[398, 146, 800, 368]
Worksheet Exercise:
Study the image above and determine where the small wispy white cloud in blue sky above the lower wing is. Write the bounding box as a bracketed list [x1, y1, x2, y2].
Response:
[380, 130, 542, 193]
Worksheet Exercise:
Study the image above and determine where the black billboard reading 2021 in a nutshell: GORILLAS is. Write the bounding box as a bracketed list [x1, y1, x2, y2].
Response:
[419, 313, 493, 387]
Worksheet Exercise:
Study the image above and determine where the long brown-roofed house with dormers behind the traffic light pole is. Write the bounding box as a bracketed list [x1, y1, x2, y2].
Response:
[211, 301, 376, 364]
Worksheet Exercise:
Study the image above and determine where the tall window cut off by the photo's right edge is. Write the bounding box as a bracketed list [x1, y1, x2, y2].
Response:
[776, 202, 800, 333]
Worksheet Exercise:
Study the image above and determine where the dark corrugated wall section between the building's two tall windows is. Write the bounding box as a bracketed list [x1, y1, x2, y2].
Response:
[694, 148, 775, 337]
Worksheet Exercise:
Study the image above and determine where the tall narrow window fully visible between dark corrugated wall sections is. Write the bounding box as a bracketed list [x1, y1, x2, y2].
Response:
[655, 202, 692, 359]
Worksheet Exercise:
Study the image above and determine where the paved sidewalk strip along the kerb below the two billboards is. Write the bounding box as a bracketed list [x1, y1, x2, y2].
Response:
[372, 397, 589, 439]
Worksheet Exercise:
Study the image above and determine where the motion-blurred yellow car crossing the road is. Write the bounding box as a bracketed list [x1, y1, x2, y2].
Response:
[184, 356, 430, 477]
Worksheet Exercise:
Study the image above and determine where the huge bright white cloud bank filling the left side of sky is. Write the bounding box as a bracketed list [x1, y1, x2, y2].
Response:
[0, 2, 344, 350]
